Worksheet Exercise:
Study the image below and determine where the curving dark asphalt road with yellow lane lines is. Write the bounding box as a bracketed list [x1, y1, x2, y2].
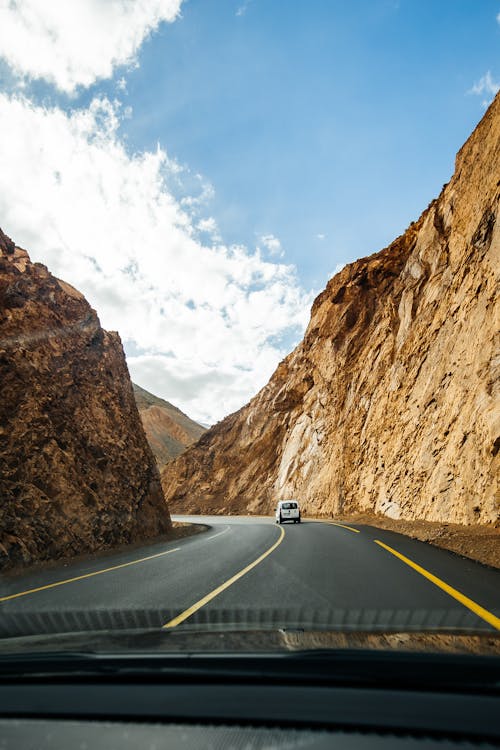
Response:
[0, 516, 500, 634]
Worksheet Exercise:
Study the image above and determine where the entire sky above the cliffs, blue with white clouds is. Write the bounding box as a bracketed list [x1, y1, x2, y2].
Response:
[0, 0, 500, 422]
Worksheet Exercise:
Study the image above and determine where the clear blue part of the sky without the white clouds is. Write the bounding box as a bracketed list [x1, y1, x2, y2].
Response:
[116, 0, 500, 288]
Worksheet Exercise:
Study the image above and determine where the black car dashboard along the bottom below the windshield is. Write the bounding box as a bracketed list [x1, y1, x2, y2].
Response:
[0, 652, 500, 750]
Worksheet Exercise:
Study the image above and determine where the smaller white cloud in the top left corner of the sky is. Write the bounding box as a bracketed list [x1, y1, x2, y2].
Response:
[0, 0, 182, 93]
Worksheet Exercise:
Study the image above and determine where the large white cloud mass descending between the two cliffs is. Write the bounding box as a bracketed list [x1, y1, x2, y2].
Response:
[0, 94, 311, 422]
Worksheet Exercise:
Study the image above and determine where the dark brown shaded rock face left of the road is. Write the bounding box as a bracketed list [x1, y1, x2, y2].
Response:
[0, 230, 171, 564]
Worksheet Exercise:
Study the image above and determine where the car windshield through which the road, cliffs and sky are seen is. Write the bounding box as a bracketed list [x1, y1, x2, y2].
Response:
[0, 0, 500, 655]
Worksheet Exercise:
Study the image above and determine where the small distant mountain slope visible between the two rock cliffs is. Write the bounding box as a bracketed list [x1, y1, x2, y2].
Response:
[132, 383, 206, 470]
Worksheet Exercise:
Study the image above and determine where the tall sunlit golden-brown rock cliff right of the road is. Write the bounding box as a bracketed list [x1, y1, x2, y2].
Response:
[162, 95, 500, 524]
